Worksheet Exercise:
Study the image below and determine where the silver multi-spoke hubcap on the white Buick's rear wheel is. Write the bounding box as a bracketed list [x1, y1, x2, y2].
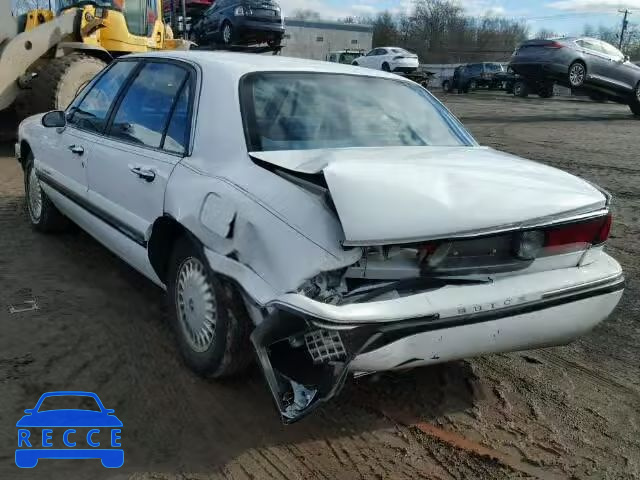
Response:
[176, 257, 217, 352]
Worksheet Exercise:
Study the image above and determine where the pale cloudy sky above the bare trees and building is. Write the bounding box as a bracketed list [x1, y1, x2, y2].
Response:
[279, 0, 640, 35]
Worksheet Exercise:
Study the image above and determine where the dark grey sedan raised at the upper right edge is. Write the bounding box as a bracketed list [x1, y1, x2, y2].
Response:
[510, 37, 640, 115]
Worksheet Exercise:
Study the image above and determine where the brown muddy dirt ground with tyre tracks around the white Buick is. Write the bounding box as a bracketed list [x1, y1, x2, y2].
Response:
[0, 93, 640, 480]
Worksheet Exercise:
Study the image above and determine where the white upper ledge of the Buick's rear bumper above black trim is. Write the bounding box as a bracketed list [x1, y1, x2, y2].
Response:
[268, 252, 623, 326]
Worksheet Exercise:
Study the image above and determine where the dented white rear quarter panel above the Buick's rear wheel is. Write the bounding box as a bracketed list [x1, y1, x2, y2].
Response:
[165, 161, 362, 304]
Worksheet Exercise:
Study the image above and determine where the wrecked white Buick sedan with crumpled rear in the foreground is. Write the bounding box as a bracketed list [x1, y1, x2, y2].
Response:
[16, 52, 624, 422]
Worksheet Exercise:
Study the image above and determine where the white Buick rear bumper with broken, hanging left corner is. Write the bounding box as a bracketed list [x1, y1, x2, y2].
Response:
[252, 254, 624, 423]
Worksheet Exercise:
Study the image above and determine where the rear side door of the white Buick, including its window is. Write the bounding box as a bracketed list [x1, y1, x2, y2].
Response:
[88, 59, 195, 277]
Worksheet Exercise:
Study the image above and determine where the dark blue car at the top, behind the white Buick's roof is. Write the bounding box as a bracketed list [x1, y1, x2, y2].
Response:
[192, 0, 284, 46]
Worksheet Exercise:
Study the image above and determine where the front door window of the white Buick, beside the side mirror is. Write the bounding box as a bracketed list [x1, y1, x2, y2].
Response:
[67, 61, 138, 133]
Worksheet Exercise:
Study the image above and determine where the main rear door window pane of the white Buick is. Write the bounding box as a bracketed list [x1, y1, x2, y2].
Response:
[109, 63, 188, 148]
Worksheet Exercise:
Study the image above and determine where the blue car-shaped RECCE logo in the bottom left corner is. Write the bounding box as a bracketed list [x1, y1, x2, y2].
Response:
[16, 392, 124, 468]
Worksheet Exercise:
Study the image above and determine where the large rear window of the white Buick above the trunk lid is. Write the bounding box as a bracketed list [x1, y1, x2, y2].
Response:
[241, 72, 474, 151]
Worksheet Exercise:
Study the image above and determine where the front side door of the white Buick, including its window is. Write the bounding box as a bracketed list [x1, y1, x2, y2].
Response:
[35, 62, 135, 206]
